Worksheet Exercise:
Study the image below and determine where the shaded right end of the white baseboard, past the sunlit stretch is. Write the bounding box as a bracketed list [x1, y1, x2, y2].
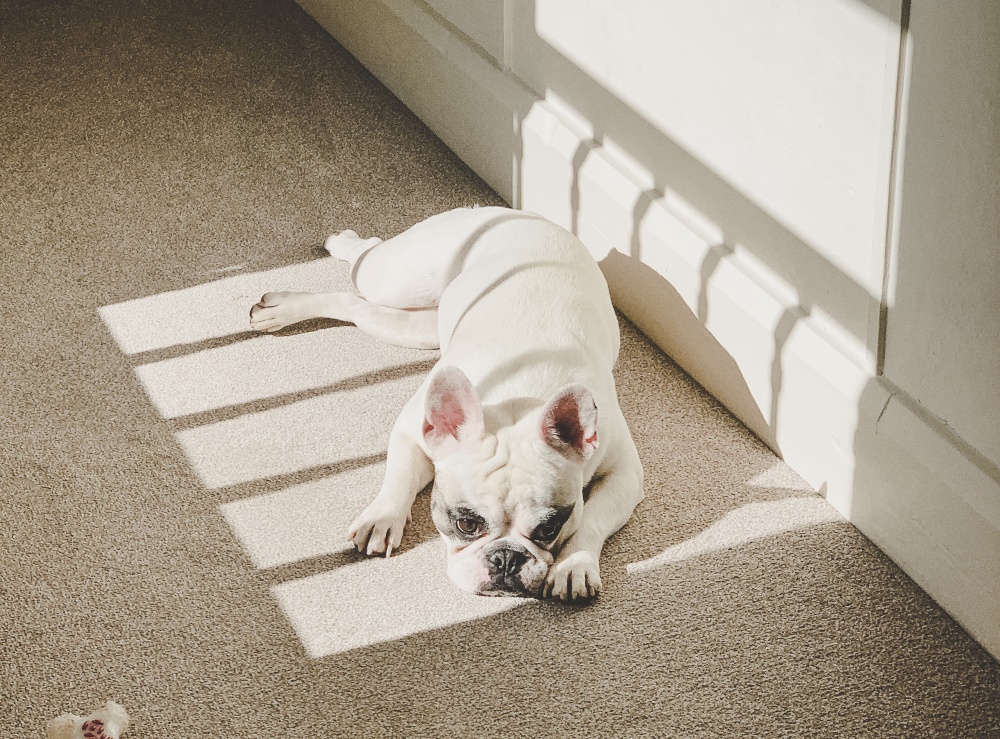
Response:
[852, 379, 1000, 656]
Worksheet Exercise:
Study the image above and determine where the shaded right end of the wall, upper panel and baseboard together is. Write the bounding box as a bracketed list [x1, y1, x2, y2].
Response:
[856, 0, 1000, 654]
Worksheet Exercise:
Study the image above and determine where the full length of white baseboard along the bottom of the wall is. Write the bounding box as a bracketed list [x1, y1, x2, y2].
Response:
[299, 0, 1000, 656]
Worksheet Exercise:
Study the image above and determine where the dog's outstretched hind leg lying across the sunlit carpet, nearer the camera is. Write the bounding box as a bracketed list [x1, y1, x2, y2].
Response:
[250, 292, 439, 349]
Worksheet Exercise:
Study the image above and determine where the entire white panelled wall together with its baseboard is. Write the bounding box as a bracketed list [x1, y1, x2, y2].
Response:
[300, 0, 1000, 653]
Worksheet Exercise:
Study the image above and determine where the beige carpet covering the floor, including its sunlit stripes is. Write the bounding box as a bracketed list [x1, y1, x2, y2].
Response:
[0, 0, 1000, 739]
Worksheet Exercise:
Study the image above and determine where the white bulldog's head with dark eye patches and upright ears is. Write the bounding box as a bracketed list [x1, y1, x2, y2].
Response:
[423, 367, 597, 597]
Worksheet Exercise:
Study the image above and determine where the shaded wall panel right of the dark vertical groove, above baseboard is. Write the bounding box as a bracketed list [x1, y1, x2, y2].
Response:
[885, 2, 1000, 464]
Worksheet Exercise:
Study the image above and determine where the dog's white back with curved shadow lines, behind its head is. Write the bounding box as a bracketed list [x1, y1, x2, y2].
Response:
[438, 208, 619, 410]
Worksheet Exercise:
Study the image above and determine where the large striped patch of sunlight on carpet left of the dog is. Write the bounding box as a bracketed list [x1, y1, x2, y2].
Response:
[99, 259, 534, 657]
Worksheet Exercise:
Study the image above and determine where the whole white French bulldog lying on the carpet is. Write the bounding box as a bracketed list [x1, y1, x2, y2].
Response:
[250, 208, 643, 600]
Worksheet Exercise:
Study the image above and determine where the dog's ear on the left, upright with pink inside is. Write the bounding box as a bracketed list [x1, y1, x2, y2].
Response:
[424, 367, 484, 454]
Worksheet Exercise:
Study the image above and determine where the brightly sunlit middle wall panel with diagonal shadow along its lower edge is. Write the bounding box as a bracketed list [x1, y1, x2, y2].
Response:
[512, 0, 899, 355]
